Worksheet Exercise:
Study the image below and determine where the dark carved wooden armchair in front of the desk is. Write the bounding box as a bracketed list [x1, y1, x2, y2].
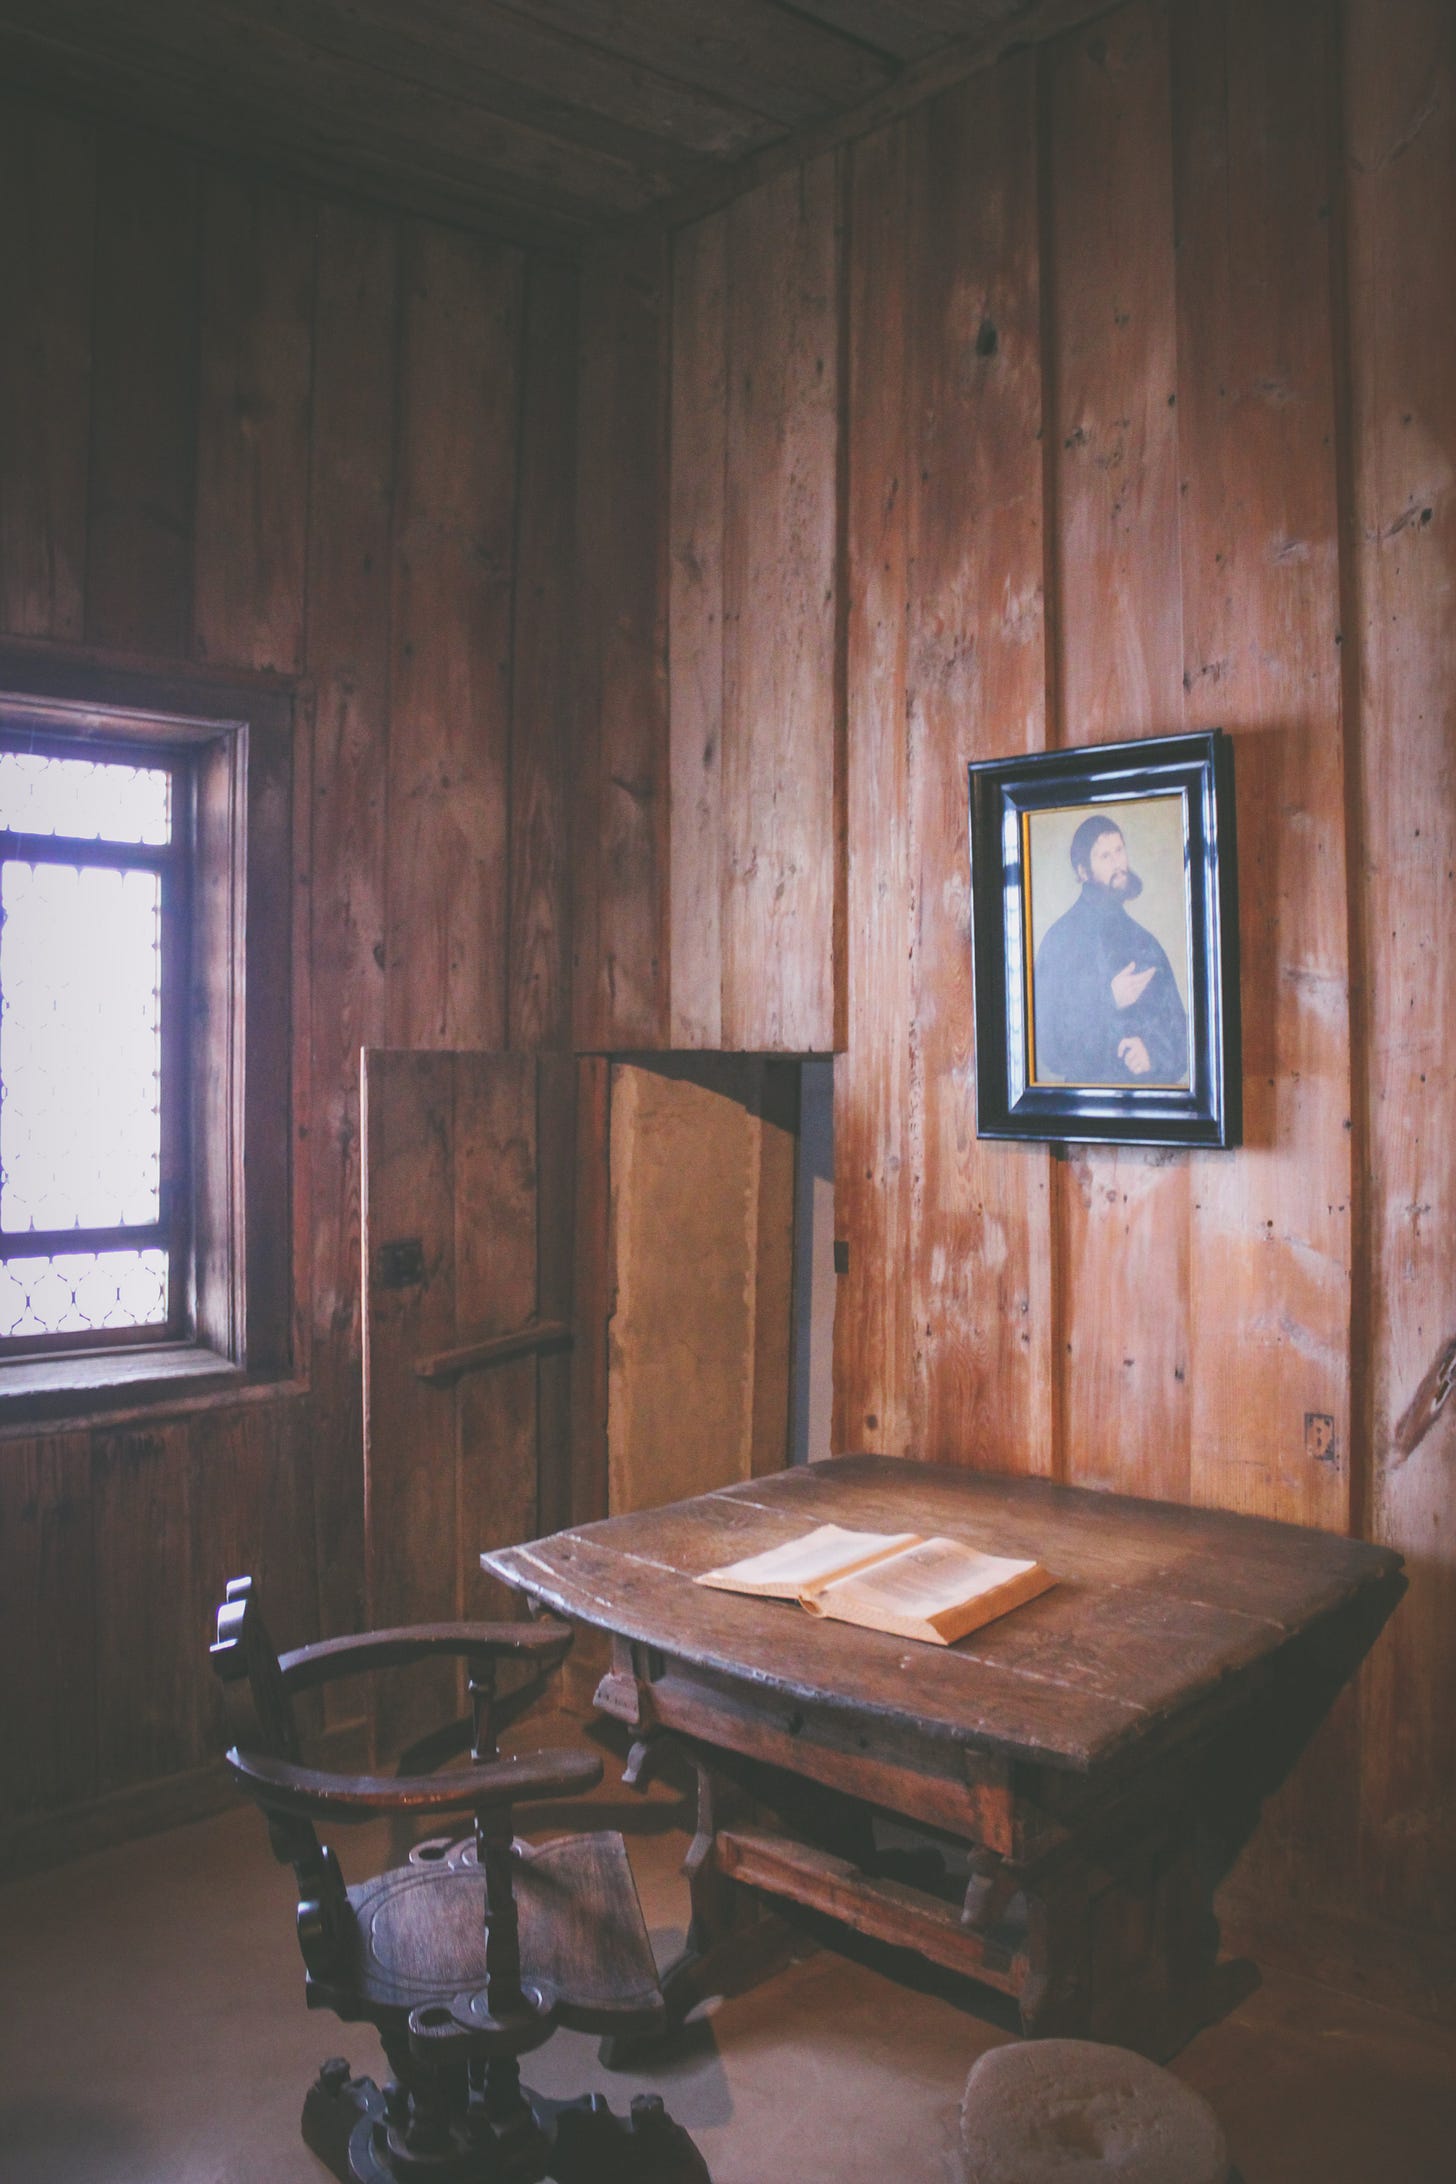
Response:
[212, 1577, 707, 2184]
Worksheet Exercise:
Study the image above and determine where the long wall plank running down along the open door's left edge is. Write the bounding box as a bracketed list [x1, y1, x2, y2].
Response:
[301, 207, 399, 1629]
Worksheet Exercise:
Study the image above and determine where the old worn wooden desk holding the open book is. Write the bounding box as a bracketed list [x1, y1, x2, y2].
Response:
[482, 1457, 1404, 2057]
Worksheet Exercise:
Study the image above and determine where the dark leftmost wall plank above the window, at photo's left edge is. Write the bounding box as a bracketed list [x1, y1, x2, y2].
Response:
[0, 98, 96, 640]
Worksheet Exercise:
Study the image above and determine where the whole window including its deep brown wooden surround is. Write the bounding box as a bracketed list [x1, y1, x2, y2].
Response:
[0, 655, 293, 1409]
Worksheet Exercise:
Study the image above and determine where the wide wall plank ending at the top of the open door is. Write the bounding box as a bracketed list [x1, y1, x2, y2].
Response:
[386, 225, 522, 1046]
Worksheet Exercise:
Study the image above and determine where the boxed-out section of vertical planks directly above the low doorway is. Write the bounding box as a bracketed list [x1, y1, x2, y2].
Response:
[576, 153, 845, 1053]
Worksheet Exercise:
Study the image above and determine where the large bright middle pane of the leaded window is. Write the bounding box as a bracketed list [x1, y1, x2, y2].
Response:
[0, 858, 162, 1231]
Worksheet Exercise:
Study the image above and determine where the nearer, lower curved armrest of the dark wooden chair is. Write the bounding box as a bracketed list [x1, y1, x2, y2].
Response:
[227, 1745, 602, 1819]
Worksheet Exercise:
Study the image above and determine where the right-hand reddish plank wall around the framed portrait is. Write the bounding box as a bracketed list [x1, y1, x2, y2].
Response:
[587, 0, 1456, 1974]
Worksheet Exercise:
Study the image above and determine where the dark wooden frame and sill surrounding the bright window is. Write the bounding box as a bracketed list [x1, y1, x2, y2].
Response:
[0, 651, 295, 1417]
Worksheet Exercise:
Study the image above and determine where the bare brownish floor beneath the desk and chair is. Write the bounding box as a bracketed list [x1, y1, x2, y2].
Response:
[0, 1738, 1456, 2184]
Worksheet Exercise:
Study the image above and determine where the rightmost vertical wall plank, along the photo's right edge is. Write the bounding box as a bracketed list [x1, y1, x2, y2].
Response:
[1345, 0, 1456, 1933]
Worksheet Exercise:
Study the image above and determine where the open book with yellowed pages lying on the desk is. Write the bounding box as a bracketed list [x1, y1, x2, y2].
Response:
[696, 1524, 1057, 1645]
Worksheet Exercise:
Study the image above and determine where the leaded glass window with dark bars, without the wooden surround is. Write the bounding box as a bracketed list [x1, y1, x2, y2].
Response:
[0, 732, 192, 1356]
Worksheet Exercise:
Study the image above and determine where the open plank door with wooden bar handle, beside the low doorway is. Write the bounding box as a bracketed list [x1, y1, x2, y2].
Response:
[362, 1048, 605, 1749]
